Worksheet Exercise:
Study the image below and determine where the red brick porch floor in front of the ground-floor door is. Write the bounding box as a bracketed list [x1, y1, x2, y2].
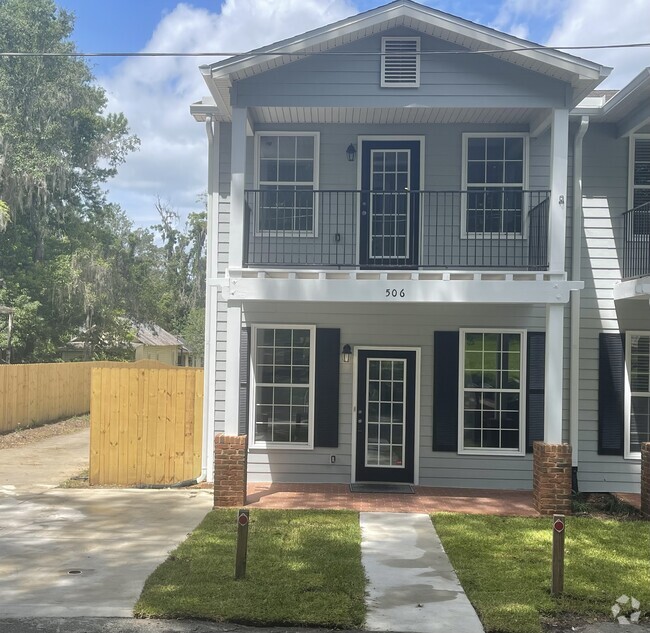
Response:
[246, 483, 539, 517]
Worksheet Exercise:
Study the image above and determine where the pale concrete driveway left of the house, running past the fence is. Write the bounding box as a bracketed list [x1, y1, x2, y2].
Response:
[0, 434, 212, 618]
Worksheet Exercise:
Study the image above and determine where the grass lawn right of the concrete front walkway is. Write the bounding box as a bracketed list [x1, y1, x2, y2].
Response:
[432, 514, 650, 633]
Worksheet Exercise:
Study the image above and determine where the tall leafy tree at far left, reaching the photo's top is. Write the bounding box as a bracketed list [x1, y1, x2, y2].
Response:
[0, 0, 139, 361]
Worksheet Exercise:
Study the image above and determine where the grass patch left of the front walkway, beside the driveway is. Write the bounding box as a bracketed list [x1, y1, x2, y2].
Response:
[134, 510, 365, 628]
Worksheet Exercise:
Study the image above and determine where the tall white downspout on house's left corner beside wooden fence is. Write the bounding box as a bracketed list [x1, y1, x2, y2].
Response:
[201, 118, 220, 481]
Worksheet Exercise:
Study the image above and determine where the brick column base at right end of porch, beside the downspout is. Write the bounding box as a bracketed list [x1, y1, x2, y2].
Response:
[533, 442, 571, 515]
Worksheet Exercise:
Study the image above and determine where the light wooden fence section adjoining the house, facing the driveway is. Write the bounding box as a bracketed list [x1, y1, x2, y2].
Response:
[89, 367, 203, 486]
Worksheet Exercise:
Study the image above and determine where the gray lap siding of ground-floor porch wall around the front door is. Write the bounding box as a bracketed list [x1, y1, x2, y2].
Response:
[244, 303, 545, 489]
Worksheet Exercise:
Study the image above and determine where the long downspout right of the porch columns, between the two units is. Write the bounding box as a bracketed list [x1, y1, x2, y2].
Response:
[569, 116, 589, 492]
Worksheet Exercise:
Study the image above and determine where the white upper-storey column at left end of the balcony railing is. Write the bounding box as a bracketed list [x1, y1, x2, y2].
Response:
[228, 108, 248, 268]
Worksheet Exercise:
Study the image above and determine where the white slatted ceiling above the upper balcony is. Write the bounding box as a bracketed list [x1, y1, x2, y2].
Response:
[251, 107, 541, 125]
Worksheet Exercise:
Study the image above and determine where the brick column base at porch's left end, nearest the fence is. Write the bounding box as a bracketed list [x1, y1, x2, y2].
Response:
[214, 435, 248, 508]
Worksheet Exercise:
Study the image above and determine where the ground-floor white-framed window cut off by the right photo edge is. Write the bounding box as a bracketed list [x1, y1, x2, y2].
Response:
[625, 332, 650, 457]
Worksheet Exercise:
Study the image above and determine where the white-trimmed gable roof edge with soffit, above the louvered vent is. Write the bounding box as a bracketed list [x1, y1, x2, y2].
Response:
[197, 0, 611, 117]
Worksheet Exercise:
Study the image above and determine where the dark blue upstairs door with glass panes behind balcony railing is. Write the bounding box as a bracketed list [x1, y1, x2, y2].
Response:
[359, 140, 420, 268]
